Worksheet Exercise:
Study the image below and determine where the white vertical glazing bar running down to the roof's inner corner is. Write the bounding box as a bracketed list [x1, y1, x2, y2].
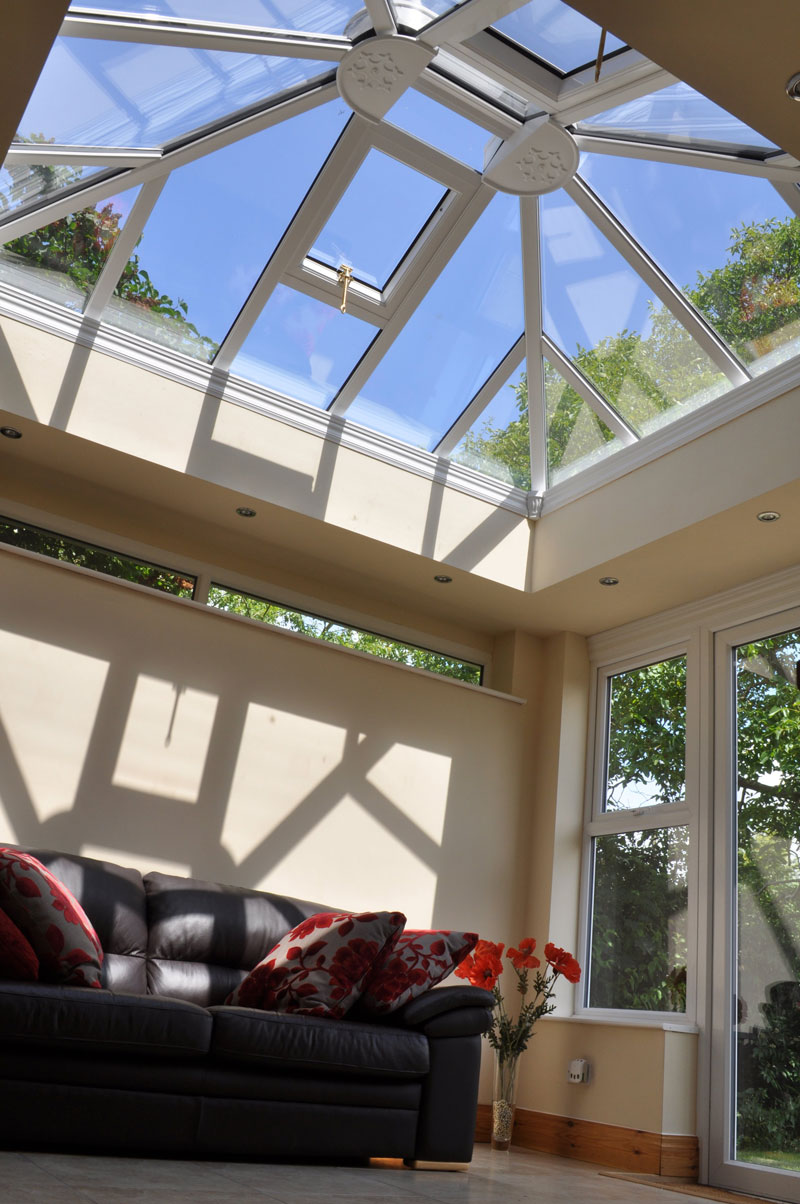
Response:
[519, 196, 547, 494]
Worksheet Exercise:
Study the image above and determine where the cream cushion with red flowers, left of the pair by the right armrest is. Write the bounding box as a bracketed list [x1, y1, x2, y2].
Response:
[225, 911, 406, 1020]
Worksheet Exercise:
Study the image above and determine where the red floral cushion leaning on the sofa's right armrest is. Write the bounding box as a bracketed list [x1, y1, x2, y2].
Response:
[359, 928, 478, 1013]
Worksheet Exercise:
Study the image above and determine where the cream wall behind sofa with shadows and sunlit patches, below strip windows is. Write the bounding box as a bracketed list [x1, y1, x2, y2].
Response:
[0, 550, 523, 929]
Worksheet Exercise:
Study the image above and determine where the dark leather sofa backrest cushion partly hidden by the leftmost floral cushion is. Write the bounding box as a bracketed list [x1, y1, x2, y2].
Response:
[19, 846, 147, 995]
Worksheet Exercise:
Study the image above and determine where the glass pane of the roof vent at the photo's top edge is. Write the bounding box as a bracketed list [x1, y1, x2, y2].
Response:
[492, 0, 625, 72]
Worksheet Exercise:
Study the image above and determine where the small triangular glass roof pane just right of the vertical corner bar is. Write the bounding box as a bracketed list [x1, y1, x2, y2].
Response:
[545, 364, 624, 485]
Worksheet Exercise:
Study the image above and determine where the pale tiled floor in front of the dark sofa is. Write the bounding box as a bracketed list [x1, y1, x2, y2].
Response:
[0, 1145, 713, 1204]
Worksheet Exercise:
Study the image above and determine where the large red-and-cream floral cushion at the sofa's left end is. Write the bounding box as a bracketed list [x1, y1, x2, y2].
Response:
[0, 848, 102, 987]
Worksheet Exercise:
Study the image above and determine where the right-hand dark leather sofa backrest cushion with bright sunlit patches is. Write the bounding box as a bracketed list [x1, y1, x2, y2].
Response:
[145, 873, 330, 1007]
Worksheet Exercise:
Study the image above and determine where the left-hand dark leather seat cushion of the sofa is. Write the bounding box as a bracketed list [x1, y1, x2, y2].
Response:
[0, 982, 211, 1058]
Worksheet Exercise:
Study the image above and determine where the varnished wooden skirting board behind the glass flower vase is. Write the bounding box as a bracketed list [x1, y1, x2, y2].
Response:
[475, 1104, 699, 1179]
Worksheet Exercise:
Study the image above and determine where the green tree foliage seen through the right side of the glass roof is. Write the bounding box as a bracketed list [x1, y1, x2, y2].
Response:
[458, 218, 800, 489]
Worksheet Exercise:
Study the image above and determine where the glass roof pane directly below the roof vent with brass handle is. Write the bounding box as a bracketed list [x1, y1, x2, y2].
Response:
[231, 284, 377, 409]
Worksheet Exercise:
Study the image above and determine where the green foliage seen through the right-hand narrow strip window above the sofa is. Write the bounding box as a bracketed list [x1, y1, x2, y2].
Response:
[208, 585, 481, 685]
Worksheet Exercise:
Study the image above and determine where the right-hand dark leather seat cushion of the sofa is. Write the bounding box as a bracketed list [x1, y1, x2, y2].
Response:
[208, 1005, 429, 1079]
